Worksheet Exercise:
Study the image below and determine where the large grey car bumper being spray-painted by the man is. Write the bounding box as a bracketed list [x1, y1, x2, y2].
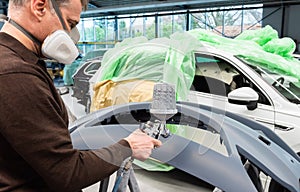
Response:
[69, 102, 300, 192]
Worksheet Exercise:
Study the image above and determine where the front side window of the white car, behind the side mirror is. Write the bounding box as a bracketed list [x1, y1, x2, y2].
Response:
[191, 53, 271, 105]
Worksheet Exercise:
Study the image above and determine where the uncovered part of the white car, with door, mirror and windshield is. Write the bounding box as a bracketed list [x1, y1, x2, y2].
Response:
[187, 47, 300, 157]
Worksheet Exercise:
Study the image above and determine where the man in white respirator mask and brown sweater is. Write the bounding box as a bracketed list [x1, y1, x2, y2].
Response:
[0, 0, 161, 191]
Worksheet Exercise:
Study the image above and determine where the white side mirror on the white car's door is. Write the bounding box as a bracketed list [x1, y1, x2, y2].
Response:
[228, 87, 259, 111]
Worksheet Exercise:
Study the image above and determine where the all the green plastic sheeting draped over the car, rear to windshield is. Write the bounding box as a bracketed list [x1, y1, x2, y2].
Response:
[99, 25, 300, 95]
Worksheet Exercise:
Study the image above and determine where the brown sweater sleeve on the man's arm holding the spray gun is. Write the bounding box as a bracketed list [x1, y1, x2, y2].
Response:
[0, 74, 132, 191]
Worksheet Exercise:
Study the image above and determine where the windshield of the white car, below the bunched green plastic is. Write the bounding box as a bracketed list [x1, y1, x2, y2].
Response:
[239, 58, 300, 104]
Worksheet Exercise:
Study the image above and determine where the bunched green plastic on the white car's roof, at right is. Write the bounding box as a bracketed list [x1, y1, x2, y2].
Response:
[188, 25, 300, 79]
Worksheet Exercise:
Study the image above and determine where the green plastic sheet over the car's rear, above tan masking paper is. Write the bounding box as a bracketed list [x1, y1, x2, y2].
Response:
[99, 33, 201, 100]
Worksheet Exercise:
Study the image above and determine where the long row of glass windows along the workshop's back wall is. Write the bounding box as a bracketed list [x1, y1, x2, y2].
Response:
[78, 5, 262, 52]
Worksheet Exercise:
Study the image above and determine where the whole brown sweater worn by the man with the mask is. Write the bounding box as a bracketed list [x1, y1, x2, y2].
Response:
[0, 33, 132, 192]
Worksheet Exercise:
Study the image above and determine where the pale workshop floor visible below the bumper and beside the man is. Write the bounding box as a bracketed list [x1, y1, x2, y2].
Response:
[62, 87, 213, 192]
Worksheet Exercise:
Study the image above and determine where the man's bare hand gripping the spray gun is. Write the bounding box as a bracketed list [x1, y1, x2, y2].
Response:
[124, 129, 162, 161]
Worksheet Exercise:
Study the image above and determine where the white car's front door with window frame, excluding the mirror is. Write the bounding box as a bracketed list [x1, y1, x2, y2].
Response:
[188, 53, 275, 130]
